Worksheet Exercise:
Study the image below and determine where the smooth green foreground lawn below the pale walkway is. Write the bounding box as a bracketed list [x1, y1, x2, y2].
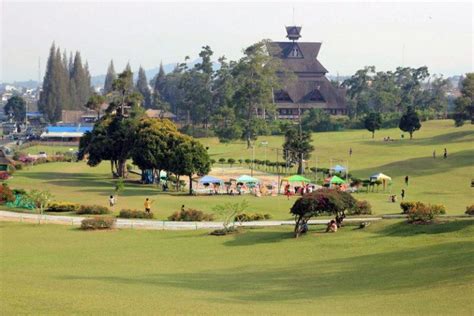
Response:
[0, 220, 474, 315]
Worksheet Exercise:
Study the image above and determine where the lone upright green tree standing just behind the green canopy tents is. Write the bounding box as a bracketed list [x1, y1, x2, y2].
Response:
[283, 128, 314, 174]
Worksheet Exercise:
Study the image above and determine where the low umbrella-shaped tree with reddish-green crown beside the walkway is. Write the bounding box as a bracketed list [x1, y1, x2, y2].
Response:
[290, 189, 356, 237]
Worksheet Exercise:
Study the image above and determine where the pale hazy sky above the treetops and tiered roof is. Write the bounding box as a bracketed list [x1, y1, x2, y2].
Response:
[0, 0, 474, 82]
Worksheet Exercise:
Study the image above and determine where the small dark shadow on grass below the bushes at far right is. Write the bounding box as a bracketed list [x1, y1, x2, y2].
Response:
[376, 219, 474, 237]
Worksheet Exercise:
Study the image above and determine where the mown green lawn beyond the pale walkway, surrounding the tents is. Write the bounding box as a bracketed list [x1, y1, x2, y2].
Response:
[4, 120, 474, 219]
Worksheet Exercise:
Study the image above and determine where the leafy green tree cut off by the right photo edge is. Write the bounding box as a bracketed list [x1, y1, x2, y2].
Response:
[455, 73, 474, 126]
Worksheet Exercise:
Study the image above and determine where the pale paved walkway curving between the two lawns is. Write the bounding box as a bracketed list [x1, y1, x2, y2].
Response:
[0, 211, 382, 230]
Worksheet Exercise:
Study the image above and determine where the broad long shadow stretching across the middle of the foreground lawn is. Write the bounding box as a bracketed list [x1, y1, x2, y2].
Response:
[58, 241, 474, 304]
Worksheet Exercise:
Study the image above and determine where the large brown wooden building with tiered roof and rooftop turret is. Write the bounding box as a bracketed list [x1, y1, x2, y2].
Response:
[268, 26, 347, 119]
